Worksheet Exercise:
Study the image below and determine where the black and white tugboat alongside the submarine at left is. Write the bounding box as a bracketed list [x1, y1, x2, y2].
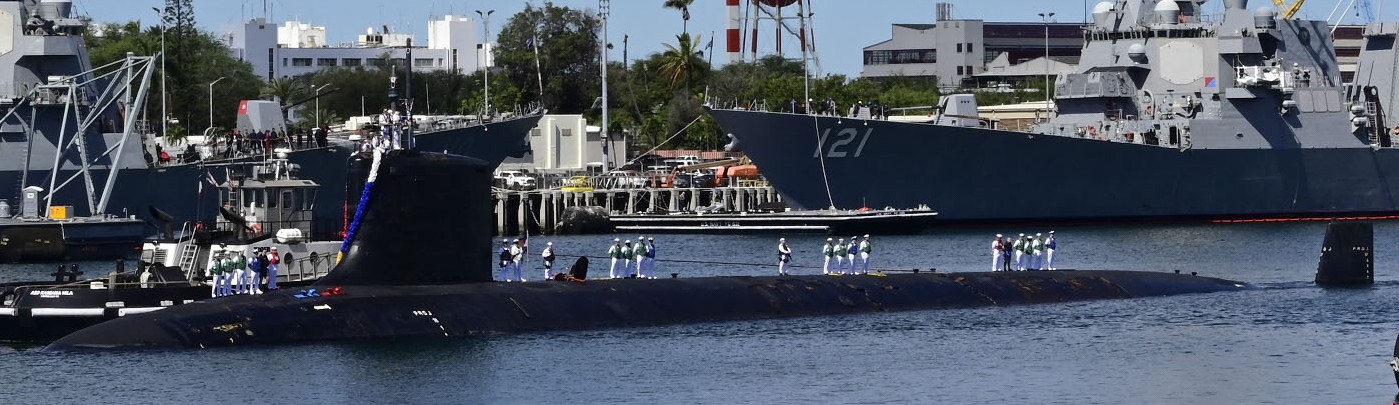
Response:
[0, 151, 340, 342]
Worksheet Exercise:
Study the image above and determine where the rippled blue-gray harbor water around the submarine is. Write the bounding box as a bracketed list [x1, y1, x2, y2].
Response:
[0, 221, 1399, 404]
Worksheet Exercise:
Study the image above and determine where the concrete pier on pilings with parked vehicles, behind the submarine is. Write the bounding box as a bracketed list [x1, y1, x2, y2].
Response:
[491, 181, 782, 235]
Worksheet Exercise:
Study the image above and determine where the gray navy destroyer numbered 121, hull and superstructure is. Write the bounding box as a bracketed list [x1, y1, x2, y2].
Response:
[709, 0, 1399, 223]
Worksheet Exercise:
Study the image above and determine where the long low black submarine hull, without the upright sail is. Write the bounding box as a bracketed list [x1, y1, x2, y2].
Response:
[48, 270, 1248, 350]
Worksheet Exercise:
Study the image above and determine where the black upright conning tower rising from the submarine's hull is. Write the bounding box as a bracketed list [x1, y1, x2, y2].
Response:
[316, 150, 492, 286]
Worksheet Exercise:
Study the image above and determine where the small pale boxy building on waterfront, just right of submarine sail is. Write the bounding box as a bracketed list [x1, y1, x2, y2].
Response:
[499, 114, 627, 171]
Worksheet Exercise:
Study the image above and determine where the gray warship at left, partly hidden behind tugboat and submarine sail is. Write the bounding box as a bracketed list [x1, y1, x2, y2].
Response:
[0, 0, 541, 248]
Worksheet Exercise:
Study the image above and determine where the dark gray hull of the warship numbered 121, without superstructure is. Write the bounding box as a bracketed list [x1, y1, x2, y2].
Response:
[709, 109, 1399, 223]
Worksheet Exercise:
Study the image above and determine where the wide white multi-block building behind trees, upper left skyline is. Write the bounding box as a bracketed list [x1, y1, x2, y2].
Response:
[229, 15, 488, 80]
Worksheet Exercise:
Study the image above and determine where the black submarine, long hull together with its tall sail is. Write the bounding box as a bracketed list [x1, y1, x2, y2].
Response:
[38, 140, 1249, 350]
